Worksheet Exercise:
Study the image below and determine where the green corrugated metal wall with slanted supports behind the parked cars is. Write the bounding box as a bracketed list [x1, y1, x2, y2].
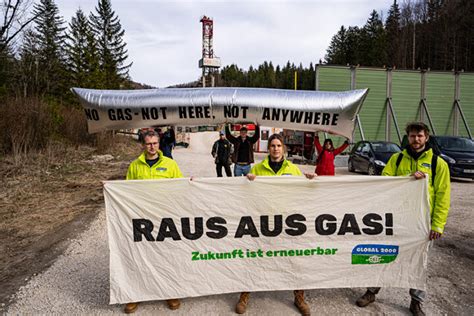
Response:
[317, 65, 474, 144]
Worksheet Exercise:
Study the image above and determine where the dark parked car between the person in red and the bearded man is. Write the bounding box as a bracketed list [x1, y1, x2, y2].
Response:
[347, 140, 401, 175]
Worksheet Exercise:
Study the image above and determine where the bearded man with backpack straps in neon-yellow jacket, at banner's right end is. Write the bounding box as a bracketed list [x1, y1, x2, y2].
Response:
[356, 122, 451, 315]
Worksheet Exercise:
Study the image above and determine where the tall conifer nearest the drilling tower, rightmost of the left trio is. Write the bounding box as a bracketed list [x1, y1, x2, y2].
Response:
[90, 0, 132, 89]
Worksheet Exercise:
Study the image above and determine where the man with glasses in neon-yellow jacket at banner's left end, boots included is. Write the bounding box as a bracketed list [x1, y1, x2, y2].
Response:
[124, 131, 183, 314]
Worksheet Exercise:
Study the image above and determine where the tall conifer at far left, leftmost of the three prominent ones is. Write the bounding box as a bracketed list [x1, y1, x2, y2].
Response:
[30, 0, 67, 96]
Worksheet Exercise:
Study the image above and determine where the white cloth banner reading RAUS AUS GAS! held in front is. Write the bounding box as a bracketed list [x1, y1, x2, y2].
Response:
[104, 176, 430, 303]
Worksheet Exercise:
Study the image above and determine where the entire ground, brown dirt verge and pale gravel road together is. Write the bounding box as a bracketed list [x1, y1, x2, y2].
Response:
[0, 134, 474, 315]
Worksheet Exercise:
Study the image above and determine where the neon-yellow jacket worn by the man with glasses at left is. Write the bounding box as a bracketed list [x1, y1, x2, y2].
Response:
[127, 150, 183, 180]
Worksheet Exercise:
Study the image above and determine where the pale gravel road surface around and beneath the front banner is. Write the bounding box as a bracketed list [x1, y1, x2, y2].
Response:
[7, 142, 474, 315]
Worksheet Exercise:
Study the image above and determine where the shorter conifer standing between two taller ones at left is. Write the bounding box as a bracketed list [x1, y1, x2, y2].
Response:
[66, 9, 100, 88]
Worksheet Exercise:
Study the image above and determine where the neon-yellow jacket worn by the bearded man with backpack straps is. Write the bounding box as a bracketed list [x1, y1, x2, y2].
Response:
[382, 149, 451, 233]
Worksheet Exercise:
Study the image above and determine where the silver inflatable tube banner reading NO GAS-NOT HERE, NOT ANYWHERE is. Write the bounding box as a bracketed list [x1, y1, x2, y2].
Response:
[72, 88, 368, 138]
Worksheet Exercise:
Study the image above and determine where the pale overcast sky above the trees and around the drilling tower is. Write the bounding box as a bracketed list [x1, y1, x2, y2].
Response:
[55, 0, 393, 88]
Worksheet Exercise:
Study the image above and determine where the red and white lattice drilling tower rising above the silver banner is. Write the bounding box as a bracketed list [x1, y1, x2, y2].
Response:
[199, 16, 221, 87]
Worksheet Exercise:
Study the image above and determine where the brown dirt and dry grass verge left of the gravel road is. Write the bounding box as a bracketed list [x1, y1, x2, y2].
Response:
[0, 137, 139, 311]
